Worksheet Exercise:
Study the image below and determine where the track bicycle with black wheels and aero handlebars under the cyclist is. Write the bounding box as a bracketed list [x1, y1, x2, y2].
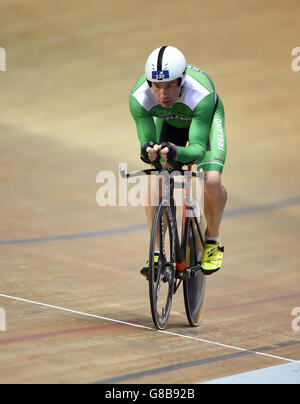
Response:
[121, 161, 206, 330]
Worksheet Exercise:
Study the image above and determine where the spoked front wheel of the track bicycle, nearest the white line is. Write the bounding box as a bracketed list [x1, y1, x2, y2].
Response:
[149, 201, 175, 330]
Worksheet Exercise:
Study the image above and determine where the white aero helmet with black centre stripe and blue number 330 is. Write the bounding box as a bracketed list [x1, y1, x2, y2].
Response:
[145, 46, 187, 87]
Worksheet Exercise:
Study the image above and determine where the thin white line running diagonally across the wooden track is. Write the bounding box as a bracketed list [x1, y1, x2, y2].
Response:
[0, 294, 300, 364]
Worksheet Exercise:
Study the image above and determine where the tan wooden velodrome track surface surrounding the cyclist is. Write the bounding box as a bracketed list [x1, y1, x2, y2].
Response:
[0, 0, 300, 383]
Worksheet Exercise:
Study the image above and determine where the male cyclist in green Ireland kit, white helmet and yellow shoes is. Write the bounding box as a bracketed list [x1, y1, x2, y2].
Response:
[129, 46, 227, 276]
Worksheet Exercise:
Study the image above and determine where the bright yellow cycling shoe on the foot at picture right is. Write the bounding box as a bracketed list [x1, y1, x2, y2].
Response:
[201, 241, 224, 275]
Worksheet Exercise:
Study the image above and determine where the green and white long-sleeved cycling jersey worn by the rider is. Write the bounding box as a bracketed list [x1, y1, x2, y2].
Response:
[129, 65, 225, 168]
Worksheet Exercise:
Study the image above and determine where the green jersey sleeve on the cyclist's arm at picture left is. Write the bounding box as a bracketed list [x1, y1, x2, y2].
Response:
[129, 94, 156, 152]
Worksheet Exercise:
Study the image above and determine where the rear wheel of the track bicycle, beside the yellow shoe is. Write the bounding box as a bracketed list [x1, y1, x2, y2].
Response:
[183, 217, 206, 327]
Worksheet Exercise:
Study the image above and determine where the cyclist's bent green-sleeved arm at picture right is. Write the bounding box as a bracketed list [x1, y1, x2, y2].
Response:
[177, 93, 215, 163]
